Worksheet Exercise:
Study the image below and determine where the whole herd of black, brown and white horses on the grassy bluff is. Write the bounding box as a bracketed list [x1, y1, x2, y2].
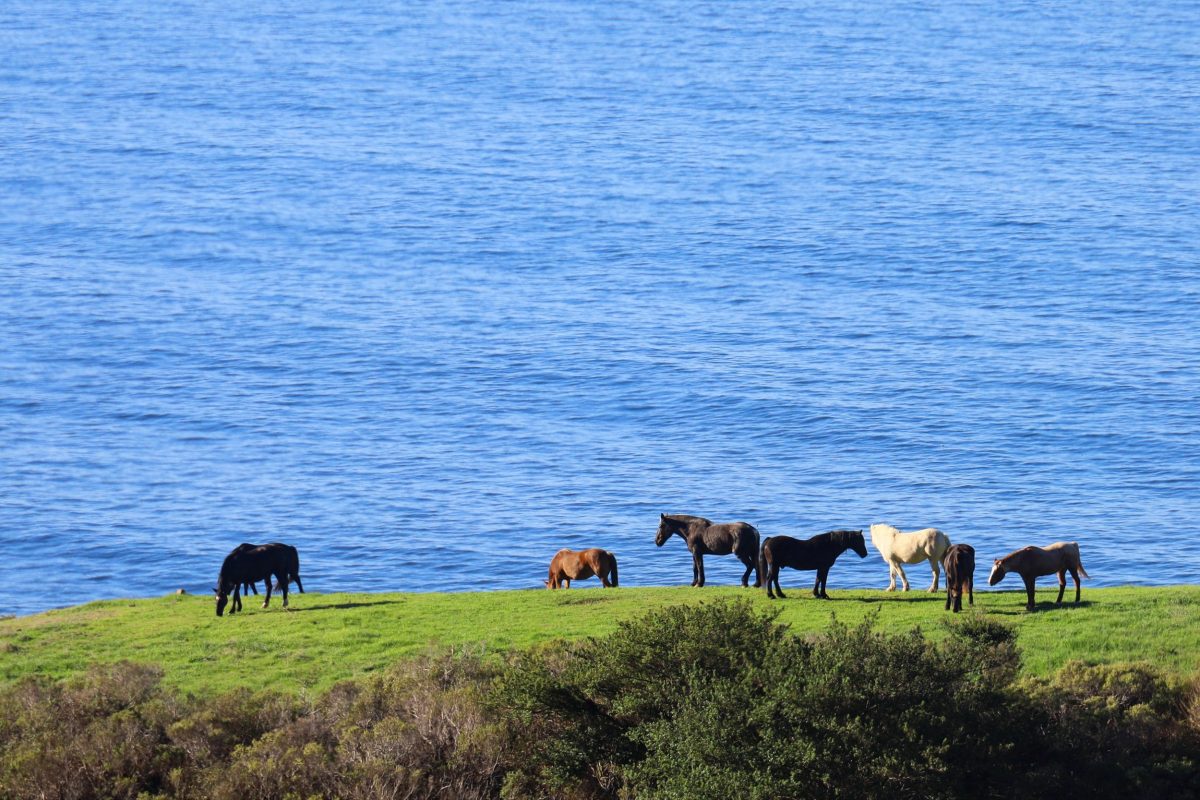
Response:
[212, 513, 1091, 616]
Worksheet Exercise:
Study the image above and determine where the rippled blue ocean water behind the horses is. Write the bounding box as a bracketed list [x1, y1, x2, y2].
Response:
[0, 0, 1200, 613]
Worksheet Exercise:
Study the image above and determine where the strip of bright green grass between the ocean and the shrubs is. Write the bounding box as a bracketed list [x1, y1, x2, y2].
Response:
[0, 587, 1200, 693]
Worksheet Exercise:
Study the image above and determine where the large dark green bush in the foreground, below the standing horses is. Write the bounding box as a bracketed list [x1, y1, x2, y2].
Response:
[497, 602, 1051, 799]
